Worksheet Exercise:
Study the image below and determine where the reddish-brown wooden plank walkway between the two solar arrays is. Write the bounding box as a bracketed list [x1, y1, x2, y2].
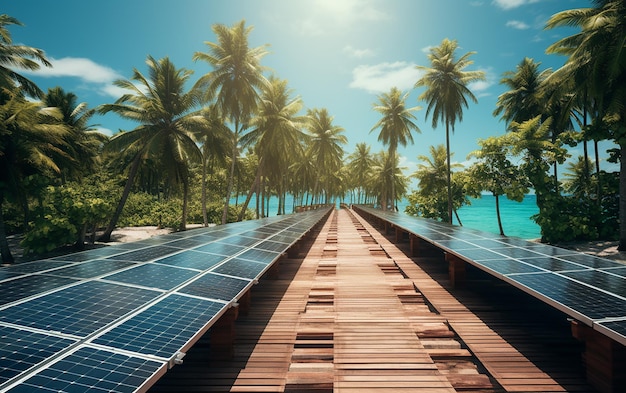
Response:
[152, 210, 594, 393]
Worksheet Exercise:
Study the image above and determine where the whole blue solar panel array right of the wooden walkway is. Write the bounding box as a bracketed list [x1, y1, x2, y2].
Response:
[355, 206, 626, 345]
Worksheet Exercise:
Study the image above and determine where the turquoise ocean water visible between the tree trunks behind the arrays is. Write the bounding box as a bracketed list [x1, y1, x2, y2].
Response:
[240, 195, 541, 240]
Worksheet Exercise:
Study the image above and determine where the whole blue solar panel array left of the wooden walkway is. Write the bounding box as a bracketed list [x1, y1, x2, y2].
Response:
[0, 208, 330, 392]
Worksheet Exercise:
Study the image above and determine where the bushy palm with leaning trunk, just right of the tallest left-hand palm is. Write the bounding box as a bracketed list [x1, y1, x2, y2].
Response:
[239, 77, 305, 220]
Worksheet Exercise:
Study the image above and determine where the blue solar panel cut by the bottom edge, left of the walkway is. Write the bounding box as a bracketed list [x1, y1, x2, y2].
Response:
[8, 347, 167, 393]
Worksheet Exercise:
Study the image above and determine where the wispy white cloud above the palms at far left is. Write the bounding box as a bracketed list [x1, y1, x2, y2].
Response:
[20, 57, 124, 98]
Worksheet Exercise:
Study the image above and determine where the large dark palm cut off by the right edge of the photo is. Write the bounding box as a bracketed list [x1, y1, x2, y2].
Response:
[546, 0, 626, 251]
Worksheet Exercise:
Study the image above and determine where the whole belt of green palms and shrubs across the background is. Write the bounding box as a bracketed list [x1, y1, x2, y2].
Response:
[0, 0, 626, 263]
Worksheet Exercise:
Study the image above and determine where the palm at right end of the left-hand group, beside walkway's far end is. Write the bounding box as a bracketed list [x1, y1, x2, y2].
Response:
[305, 108, 348, 203]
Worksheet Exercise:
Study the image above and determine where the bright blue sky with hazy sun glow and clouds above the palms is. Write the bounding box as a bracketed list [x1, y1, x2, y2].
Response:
[6, 0, 613, 178]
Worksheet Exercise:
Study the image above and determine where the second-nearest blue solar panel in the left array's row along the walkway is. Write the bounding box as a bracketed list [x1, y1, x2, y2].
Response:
[93, 294, 227, 359]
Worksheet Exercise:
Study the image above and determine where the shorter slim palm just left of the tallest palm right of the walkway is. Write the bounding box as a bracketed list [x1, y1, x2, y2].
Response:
[370, 87, 421, 211]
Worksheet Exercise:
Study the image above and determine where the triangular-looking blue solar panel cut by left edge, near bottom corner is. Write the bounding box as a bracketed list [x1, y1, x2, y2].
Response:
[0, 326, 76, 384]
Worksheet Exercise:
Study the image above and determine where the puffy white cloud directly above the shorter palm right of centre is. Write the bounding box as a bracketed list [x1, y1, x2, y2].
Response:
[350, 61, 423, 93]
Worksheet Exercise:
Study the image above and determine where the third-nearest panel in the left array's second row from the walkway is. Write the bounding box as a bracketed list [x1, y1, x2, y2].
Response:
[103, 263, 198, 290]
